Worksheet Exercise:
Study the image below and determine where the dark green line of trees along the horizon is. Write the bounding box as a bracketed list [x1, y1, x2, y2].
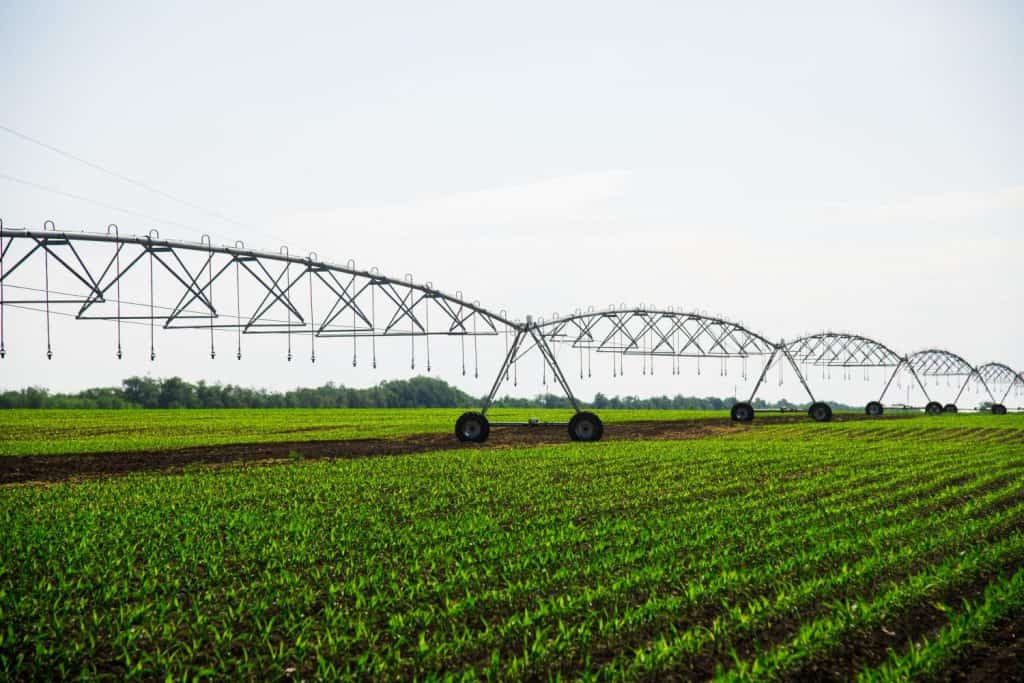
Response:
[0, 377, 845, 411]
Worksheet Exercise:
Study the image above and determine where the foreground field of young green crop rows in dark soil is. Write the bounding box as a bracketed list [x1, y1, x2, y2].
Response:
[0, 414, 1024, 681]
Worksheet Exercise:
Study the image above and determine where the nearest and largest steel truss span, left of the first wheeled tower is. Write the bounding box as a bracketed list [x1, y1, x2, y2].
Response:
[0, 223, 518, 360]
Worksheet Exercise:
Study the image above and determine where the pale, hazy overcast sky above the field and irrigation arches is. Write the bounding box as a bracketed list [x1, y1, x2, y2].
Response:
[0, 2, 1024, 397]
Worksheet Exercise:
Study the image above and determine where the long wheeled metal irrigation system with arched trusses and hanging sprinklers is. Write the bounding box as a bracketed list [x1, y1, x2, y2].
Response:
[0, 221, 1024, 442]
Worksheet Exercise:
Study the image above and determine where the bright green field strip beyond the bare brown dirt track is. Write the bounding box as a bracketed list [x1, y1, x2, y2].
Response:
[0, 409, 728, 456]
